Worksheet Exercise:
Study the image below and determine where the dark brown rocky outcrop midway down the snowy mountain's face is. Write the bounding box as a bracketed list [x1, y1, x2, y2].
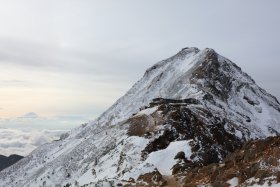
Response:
[128, 98, 244, 169]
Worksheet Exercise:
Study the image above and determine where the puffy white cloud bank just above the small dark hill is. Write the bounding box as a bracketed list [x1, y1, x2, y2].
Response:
[0, 128, 66, 156]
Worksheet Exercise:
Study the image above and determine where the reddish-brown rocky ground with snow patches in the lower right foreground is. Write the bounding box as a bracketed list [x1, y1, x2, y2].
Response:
[124, 136, 280, 187]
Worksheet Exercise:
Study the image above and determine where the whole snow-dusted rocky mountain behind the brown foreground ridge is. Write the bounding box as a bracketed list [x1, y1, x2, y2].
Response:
[0, 48, 280, 187]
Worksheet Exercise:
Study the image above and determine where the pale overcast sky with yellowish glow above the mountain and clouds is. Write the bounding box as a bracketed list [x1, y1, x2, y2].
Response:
[0, 0, 280, 129]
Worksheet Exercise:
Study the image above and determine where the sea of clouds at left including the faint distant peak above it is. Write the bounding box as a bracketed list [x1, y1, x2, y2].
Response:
[0, 112, 83, 156]
